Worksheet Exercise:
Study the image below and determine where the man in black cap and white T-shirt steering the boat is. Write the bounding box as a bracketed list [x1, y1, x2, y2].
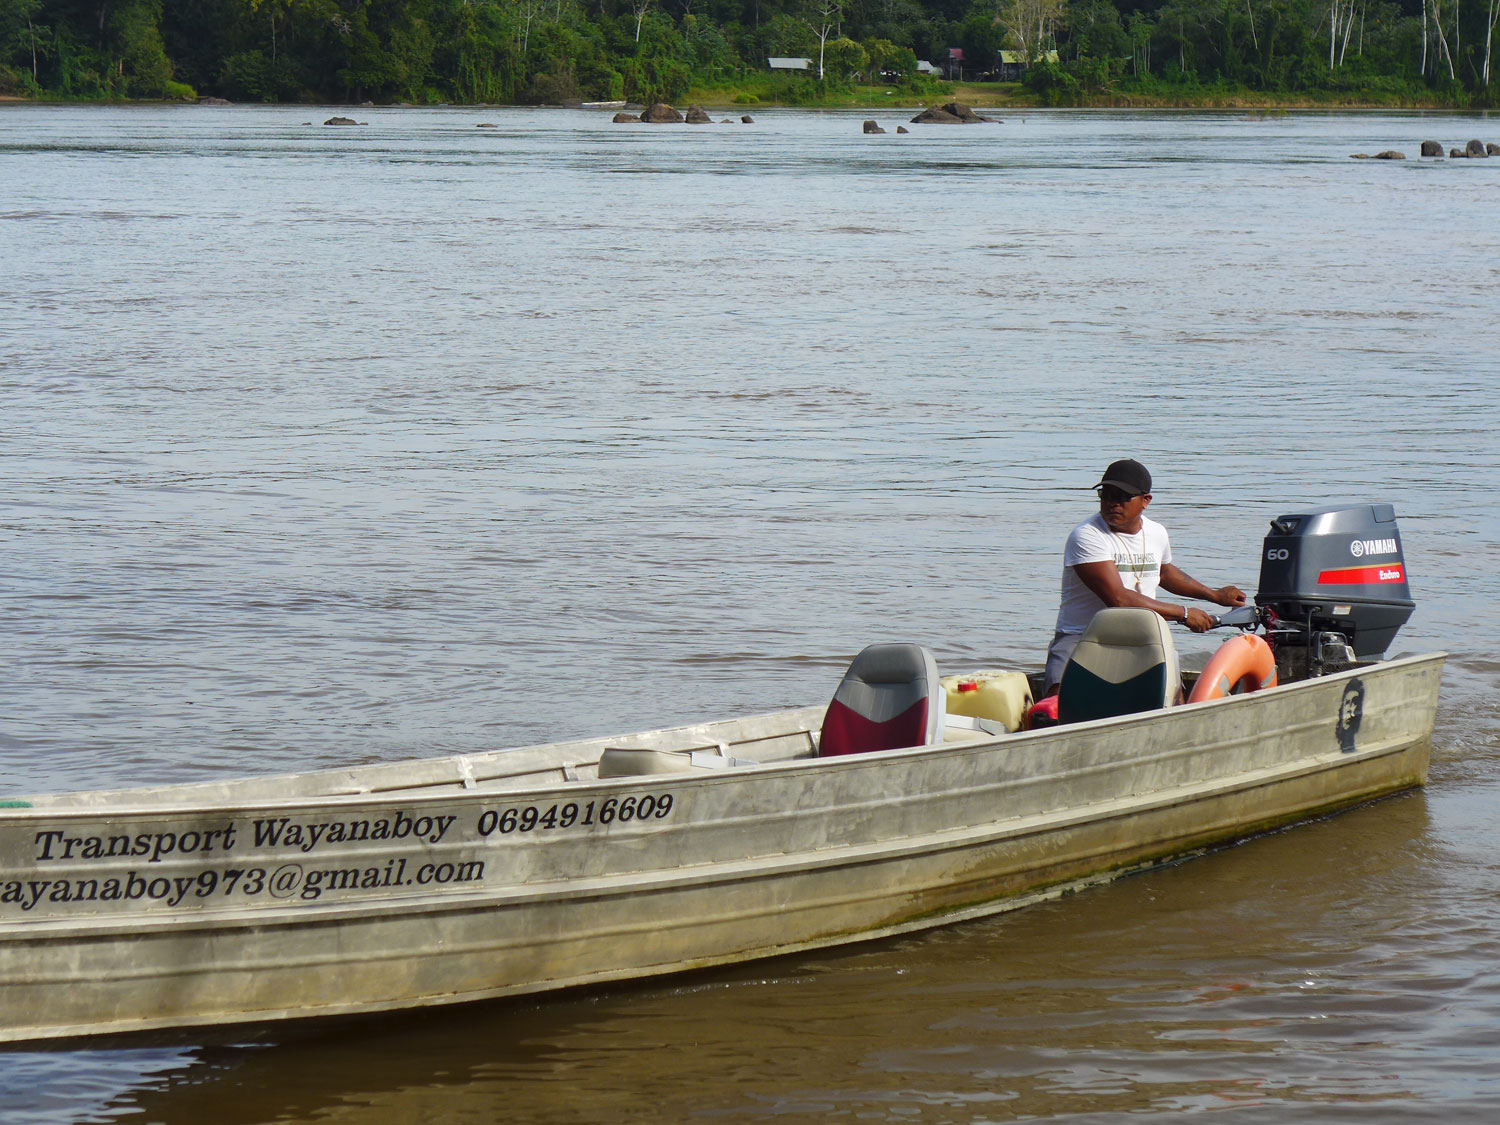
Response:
[1047, 458, 1245, 695]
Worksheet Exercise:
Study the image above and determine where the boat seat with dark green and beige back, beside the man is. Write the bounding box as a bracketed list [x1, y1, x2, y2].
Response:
[1058, 606, 1182, 723]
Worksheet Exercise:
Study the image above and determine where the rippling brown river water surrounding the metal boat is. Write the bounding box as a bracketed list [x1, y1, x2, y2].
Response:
[0, 107, 1500, 1125]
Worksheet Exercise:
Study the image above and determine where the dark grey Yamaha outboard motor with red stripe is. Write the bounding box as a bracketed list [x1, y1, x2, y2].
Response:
[1256, 504, 1416, 683]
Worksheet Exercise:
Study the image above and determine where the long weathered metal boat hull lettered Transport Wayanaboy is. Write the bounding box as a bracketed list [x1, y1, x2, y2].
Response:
[0, 654, 1443, 1043]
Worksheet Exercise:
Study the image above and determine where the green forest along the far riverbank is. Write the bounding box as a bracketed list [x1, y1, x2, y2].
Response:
[0, 0, 1500, 107]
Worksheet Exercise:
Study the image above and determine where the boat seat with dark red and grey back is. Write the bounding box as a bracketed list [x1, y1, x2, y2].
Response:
[818, 644, 947, 758]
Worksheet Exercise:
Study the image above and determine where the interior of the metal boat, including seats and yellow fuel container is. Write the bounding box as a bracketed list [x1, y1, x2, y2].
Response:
[9, 611, 1275, 809]
